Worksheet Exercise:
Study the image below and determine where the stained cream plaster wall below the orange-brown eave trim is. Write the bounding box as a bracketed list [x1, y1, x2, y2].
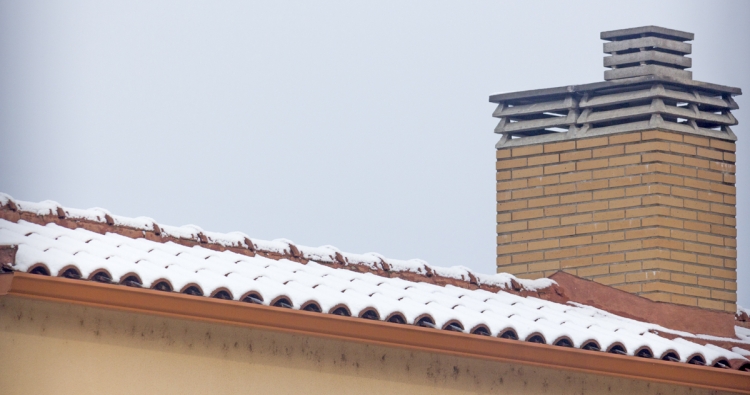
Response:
[0, 296, 732, 395]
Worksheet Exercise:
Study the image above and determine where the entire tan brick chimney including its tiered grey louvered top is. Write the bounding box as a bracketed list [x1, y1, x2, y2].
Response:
[490, 26, 742, 313]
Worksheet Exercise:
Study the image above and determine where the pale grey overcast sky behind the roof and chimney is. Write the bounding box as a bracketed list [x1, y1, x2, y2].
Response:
[0, 0, 750, 307]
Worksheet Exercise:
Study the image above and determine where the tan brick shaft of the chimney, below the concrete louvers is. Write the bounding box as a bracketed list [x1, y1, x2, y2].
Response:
[497, 131, 737, 313]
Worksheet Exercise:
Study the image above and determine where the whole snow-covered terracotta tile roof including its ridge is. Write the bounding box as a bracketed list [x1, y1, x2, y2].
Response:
[0, 194, 750, 376]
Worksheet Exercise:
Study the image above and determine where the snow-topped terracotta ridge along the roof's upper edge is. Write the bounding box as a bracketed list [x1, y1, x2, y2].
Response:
[0, 192, 567, 303]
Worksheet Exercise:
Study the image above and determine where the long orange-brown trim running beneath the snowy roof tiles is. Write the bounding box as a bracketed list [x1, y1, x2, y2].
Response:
[3, 272, 750, 394]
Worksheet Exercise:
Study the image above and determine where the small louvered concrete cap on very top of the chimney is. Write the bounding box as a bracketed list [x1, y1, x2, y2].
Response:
[601, 26, 694, 81]
